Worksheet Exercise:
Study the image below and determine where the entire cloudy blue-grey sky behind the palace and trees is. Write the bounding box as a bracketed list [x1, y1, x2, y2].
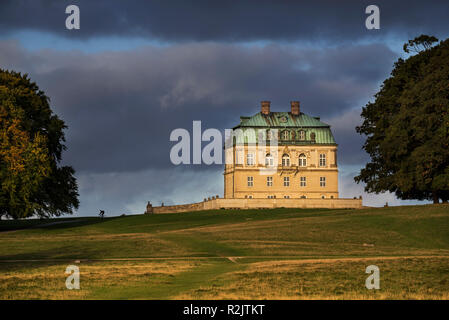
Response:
[0, 0, 449, 216]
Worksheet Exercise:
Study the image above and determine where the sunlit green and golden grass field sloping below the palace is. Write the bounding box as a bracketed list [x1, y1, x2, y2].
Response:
[0, 205, 449, 299]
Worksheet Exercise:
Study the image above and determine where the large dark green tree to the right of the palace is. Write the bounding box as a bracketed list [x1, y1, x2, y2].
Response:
[355, 36, 449, 203]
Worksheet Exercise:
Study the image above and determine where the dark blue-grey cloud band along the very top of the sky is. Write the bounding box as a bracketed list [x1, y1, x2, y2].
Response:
[0, 0, 449, 41]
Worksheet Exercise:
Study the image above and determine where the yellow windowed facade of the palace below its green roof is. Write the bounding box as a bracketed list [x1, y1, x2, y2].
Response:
[224, 145, 338, 199]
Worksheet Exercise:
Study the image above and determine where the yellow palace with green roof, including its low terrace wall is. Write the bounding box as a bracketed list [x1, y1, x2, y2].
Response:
[145, 101, 363, 214]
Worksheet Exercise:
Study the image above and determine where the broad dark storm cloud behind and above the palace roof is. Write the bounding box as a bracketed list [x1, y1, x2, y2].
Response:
[0, 41, 395, 173]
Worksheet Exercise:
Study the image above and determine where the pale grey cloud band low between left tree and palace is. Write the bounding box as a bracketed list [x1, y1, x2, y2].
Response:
[78, 168, 223, 216]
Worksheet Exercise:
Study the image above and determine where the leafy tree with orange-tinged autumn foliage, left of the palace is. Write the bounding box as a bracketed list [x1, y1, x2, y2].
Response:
[0, 69, 79, 219]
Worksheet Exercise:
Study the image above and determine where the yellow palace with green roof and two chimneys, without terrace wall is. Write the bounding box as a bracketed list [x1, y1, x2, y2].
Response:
[224, 101, 338, 199]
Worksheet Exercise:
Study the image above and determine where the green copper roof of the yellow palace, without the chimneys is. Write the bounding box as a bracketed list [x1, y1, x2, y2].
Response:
[234, 112, 336, 145]
